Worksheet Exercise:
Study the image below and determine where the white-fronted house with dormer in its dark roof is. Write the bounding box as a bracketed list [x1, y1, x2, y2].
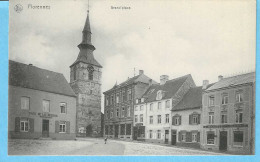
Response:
[134, 75, 195, 144]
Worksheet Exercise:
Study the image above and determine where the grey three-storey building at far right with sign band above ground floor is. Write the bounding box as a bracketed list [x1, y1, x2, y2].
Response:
[201, 73, 255, 154]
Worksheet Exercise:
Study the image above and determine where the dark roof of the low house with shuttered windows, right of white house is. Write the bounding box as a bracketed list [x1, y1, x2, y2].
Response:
[172, 86, 202, 111]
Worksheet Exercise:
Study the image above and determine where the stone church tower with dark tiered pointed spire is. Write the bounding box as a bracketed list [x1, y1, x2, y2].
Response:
[70, 11, 102, 136]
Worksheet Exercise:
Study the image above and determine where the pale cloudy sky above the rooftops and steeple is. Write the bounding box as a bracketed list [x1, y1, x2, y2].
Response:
[9, 0, 256, 111]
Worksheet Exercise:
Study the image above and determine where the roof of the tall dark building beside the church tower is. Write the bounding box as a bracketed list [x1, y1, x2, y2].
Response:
[104, 74, 158, 93]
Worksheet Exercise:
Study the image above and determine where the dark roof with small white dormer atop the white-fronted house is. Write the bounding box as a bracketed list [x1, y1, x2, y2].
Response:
[143, 74, 191, 102]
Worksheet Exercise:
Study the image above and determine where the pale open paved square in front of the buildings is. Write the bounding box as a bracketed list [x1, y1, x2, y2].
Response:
[8, 138, 225, 155]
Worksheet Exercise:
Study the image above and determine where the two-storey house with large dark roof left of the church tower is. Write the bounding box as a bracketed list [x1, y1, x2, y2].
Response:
[8, 60, 76, 139]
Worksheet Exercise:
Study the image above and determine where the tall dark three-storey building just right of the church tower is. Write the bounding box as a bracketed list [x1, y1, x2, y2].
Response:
[104, 70, 156, 139]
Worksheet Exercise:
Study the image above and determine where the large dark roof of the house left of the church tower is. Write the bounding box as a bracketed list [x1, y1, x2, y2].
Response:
[9, 60, 76, 97]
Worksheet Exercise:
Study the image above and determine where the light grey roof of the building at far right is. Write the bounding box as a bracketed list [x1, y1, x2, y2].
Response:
[206, 72, 255, 91]
